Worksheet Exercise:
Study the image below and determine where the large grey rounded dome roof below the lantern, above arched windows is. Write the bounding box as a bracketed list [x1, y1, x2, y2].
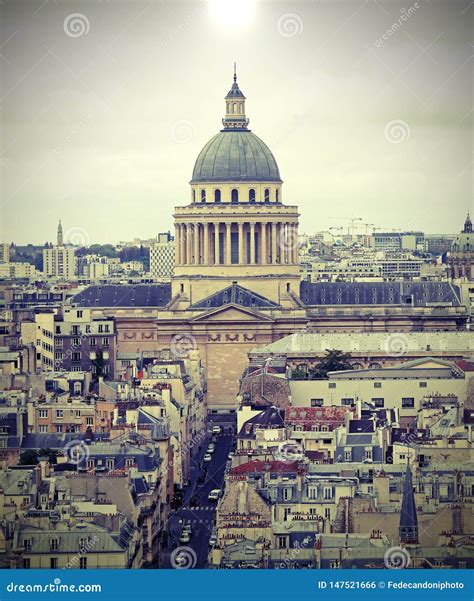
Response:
[191, 129, 281, 184]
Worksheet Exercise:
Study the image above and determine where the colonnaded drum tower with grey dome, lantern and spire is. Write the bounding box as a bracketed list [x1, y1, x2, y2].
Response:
[172, 67, 300, 308]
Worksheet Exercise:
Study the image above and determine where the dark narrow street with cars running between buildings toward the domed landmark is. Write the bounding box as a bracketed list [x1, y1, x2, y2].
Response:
[161, 426, 234, 568]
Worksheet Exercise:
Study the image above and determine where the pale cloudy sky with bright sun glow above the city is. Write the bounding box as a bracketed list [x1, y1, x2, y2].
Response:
[0, 0, 474, 244]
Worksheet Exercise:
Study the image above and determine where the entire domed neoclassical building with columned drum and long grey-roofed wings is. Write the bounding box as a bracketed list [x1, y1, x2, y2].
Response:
[72, 69, 467, 411]
